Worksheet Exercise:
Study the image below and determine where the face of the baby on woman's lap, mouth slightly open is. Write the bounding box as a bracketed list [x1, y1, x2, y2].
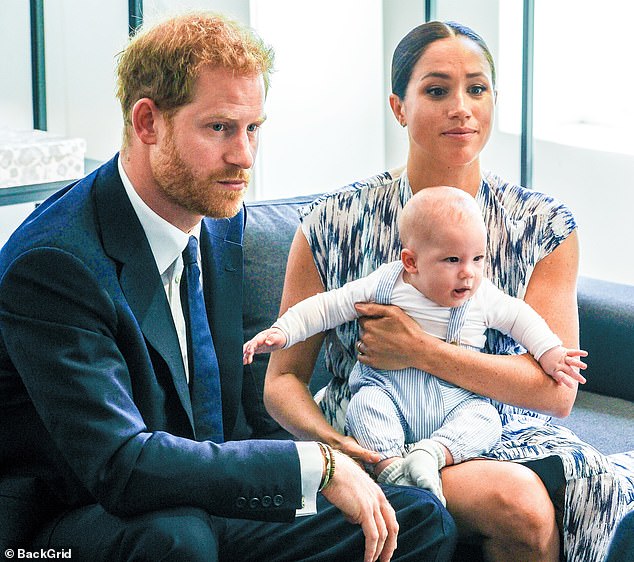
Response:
[408, 220, 486, 307]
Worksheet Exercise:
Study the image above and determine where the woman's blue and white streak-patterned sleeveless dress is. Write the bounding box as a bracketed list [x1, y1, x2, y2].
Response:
[300, 168, 634, 562]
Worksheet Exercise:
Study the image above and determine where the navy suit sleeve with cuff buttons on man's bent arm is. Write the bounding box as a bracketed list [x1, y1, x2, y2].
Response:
[0, 248, 302, 521]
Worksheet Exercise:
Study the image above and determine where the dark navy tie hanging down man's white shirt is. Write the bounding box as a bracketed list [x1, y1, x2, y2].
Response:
[181, 236, 224, 443]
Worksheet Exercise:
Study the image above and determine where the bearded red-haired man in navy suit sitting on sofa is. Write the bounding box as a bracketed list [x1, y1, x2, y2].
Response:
[0, 14, 455, 561]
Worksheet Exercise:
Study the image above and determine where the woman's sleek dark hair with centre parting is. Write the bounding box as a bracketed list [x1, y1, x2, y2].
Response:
[392, 21, 495, 99]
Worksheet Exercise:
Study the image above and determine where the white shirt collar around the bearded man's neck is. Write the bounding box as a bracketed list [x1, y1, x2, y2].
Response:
[117, 158, 200, 275]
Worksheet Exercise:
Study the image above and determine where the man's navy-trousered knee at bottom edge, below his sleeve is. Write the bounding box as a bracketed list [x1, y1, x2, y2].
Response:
[120, 508, 218, 562]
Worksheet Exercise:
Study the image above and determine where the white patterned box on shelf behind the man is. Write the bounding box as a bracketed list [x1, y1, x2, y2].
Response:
[0, 128, 86, 188]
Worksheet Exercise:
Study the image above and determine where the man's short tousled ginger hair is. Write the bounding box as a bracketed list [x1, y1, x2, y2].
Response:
[117, 12, 274, 144]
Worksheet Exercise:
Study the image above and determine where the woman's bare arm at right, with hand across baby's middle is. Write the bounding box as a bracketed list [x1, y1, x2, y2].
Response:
[357, 232, 579, 417]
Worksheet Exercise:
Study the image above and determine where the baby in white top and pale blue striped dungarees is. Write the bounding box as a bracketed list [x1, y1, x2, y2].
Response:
[244, 187, 587, 502]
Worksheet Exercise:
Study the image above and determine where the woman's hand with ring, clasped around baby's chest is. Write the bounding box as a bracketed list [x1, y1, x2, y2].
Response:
[355, 303, 439, 370]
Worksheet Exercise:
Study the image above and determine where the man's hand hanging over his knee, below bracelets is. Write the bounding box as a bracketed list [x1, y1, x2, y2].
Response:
[322, 451, 398, 562]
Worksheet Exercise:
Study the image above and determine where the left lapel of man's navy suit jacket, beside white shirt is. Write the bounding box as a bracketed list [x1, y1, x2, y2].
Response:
[95, 157, 193, 428]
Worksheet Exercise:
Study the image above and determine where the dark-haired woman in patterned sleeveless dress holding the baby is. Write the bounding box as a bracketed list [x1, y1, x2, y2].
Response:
[265, 22, 625, 560]
